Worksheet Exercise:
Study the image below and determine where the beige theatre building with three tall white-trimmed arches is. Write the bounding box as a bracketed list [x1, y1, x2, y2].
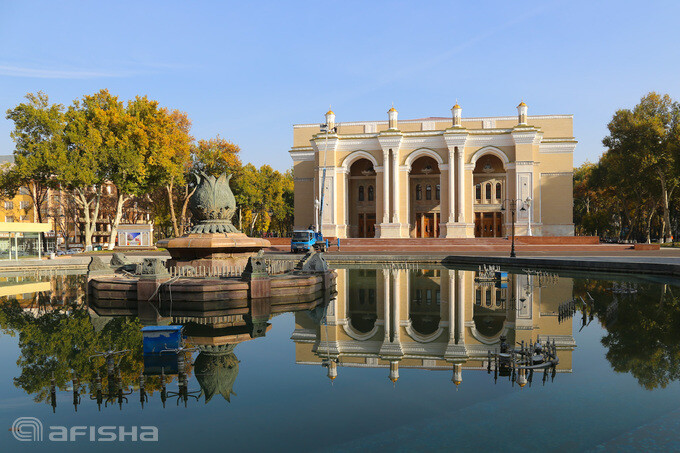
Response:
[290, 102, 577, 238]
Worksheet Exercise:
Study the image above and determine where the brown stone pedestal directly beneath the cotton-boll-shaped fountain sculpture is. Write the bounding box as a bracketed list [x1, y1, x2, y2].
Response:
[158, 233, 271, 270]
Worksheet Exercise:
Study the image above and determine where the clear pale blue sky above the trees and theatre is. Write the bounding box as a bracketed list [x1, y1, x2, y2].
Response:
[0, 0, 680, 170]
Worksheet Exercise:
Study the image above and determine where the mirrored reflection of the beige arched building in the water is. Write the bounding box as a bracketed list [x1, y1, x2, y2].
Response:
[292, 267, 576, 385]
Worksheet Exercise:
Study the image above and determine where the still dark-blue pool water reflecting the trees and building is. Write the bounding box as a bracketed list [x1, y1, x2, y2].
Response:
[0, 263, 680, 451]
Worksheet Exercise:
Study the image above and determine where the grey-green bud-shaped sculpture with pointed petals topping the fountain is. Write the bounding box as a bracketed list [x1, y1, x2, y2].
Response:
[189, 172, 239, 233]
